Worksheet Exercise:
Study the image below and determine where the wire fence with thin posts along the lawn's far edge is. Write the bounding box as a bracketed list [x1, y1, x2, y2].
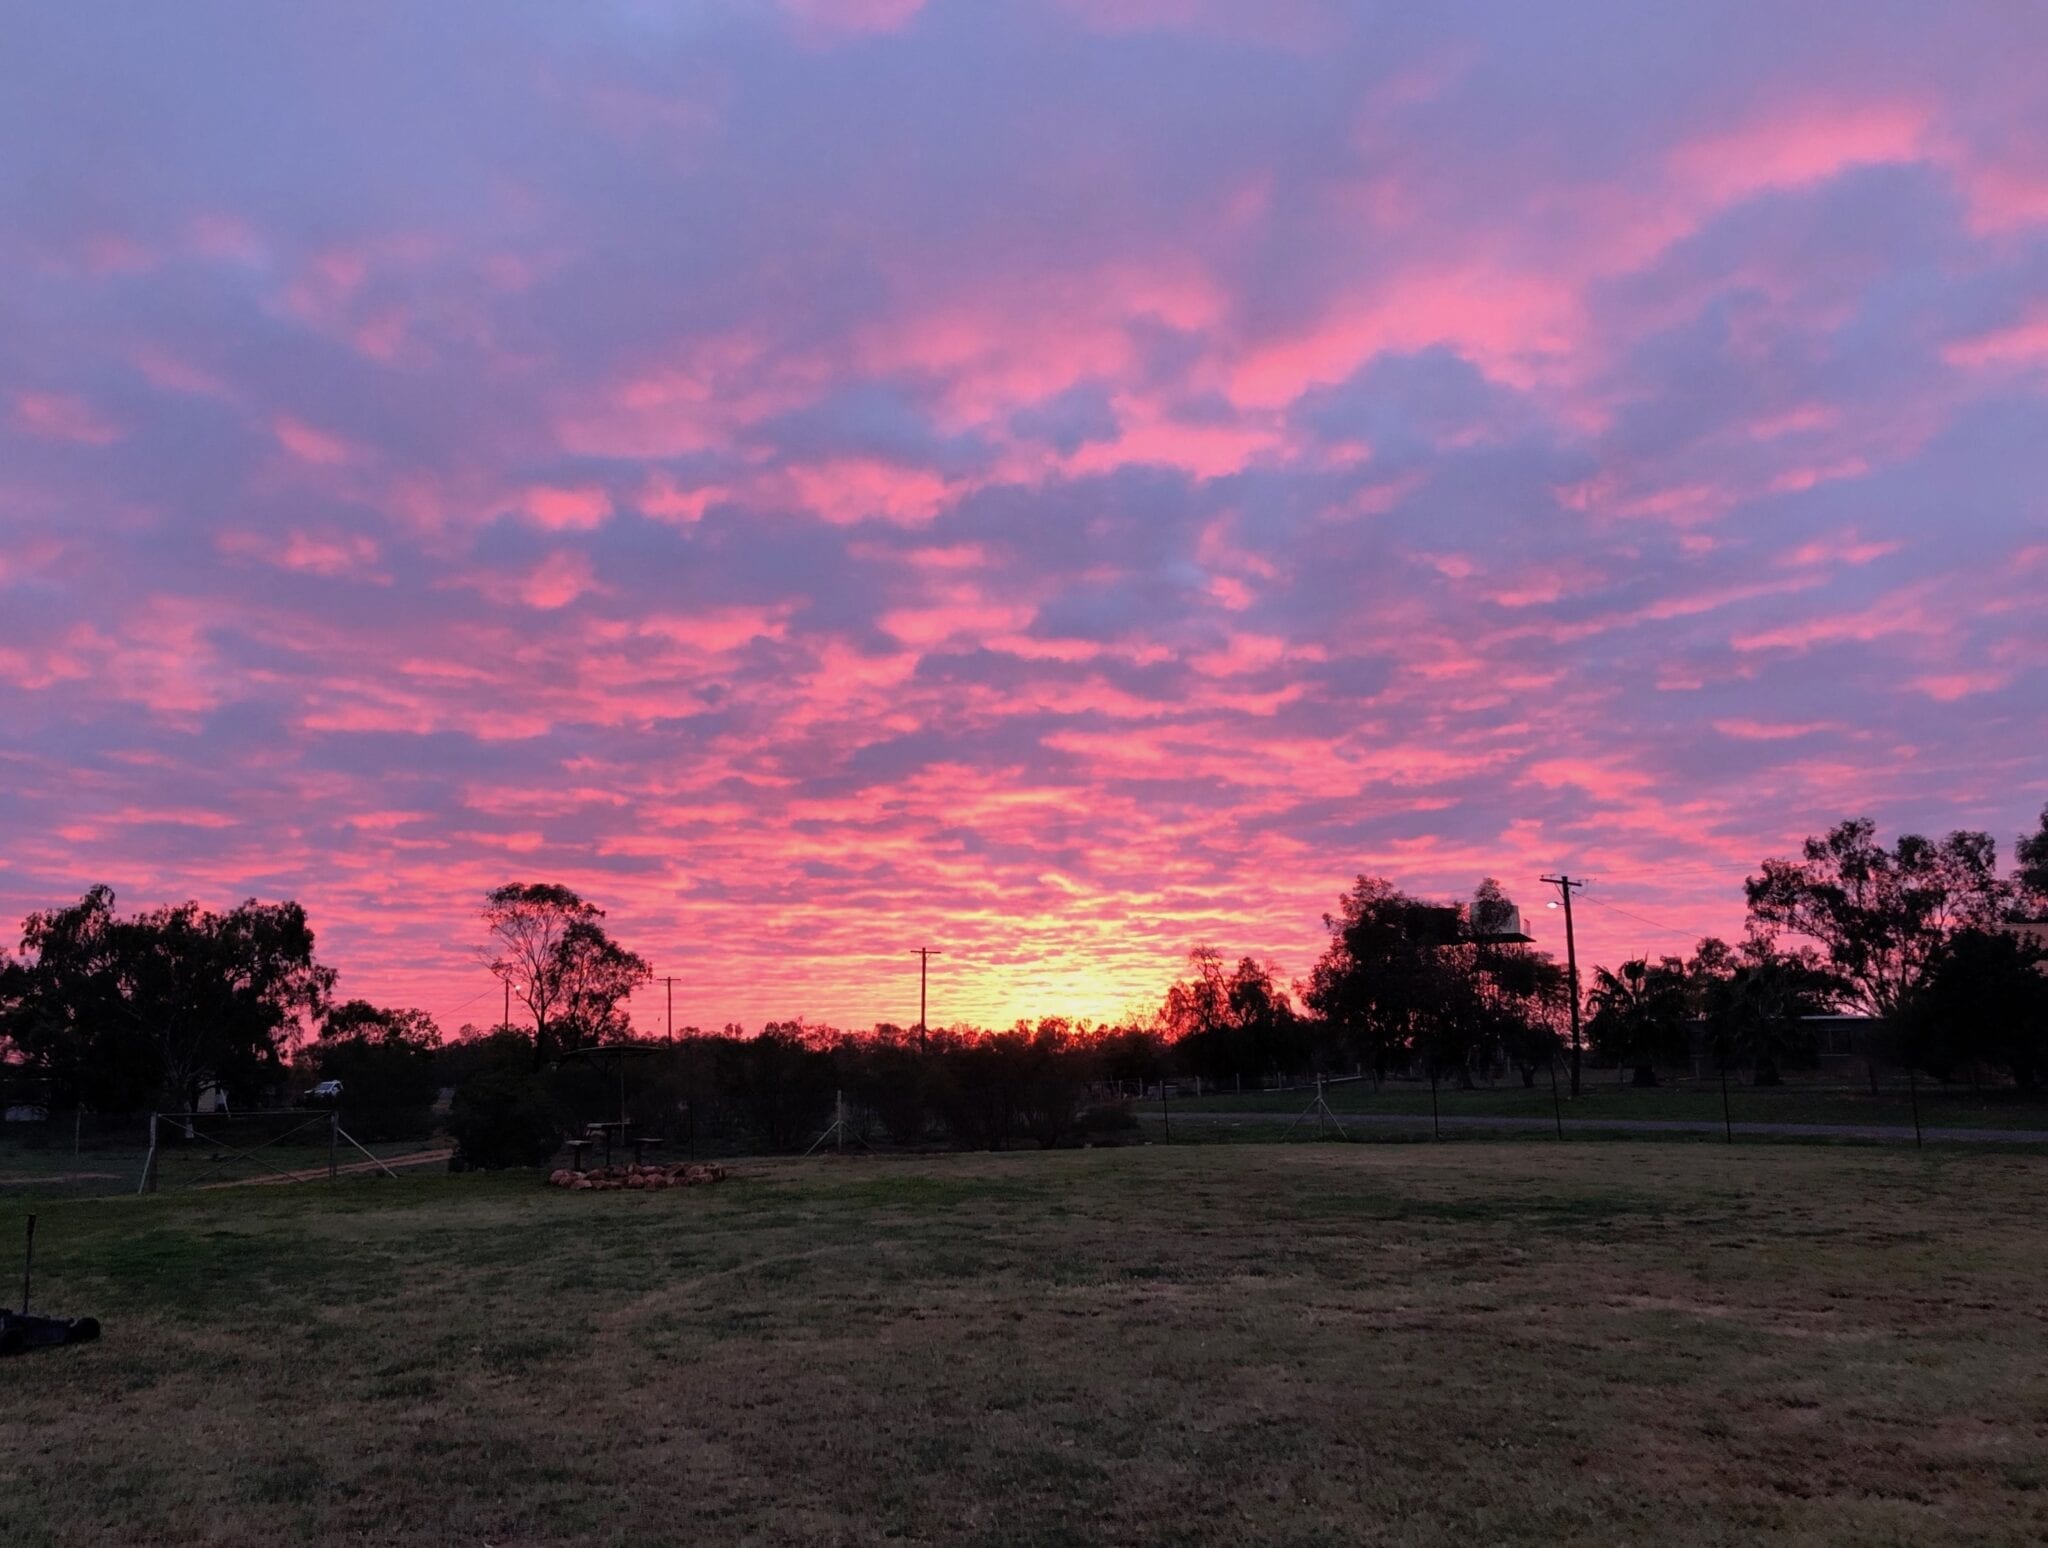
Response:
[0, 1065, 2048, 1198]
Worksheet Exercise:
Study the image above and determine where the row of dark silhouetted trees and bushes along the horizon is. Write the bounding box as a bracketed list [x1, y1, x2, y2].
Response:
[0, 811, 2048, 1155]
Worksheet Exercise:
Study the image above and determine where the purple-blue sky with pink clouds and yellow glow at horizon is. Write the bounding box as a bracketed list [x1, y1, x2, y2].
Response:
[0, 0, 2048, 1030]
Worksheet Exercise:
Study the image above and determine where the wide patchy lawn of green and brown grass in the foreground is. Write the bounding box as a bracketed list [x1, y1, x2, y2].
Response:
[0, 1143, 2048, 1544]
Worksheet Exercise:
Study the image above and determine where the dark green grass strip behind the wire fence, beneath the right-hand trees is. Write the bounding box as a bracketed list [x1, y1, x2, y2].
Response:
[1147, 1071, 2048, 1130]
